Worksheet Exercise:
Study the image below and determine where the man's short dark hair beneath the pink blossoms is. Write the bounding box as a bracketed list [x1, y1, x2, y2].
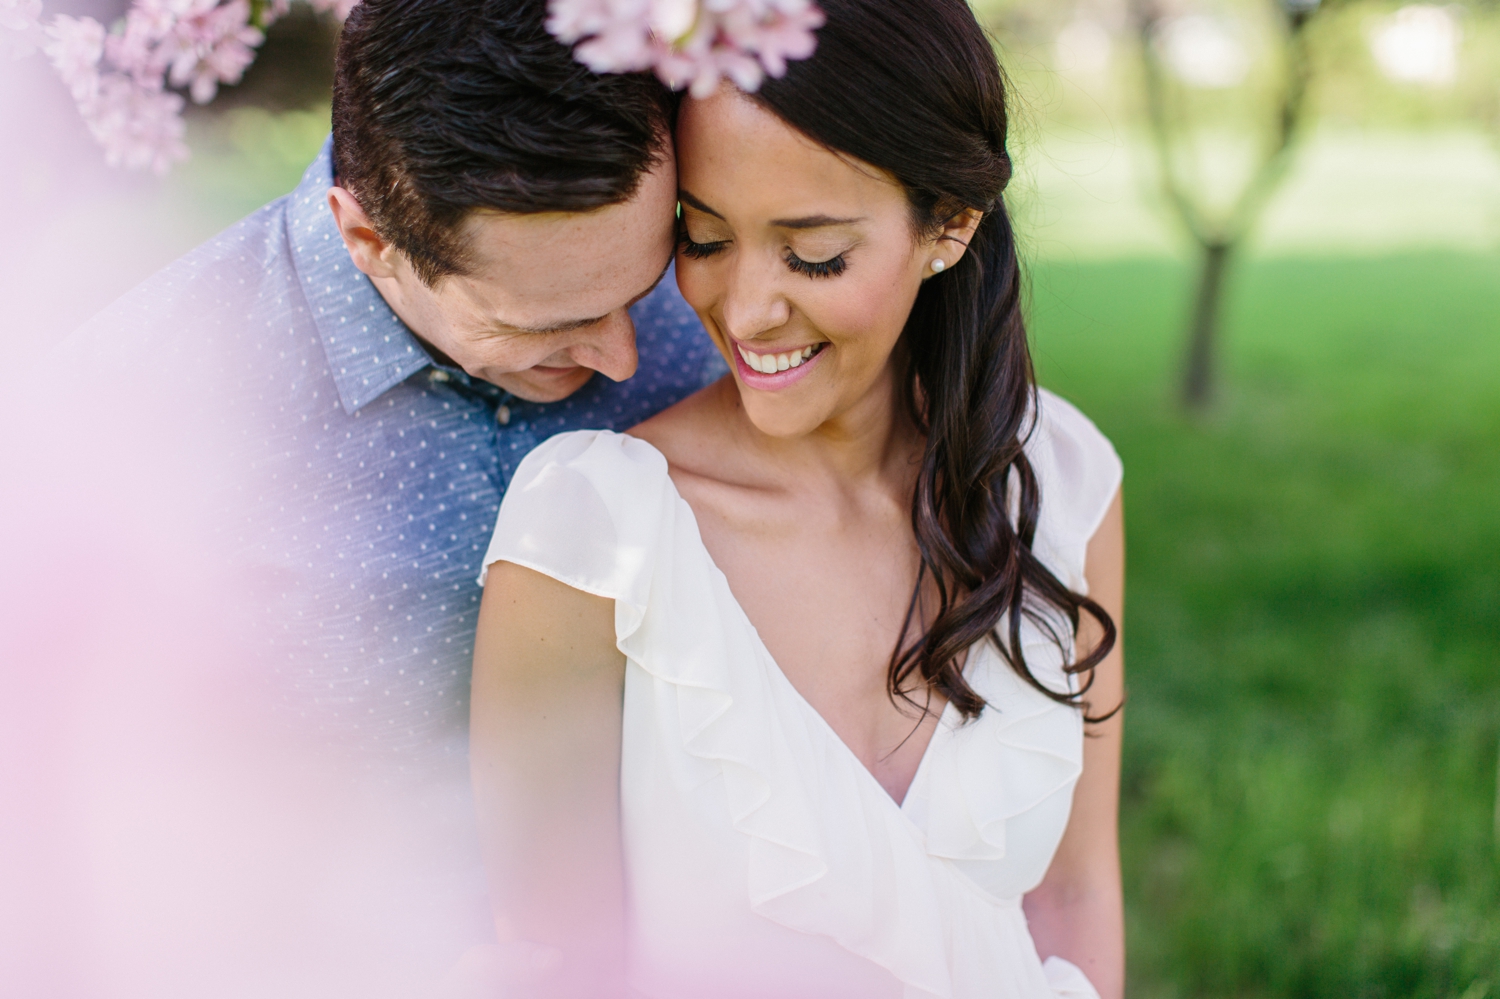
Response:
[333, 0, 675, 285]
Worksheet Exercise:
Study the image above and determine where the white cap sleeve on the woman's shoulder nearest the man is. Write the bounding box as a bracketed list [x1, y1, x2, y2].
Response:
[479, 431, 671, 600]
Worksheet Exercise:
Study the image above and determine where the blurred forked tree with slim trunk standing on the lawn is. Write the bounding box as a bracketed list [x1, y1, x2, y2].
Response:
[1131, 0, 1340, 410]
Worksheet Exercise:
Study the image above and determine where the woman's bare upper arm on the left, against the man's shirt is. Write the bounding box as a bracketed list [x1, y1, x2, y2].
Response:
[470, 563, 626, 999]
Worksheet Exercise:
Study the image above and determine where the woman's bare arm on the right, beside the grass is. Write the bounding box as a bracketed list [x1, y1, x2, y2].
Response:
[1025, 494, 1125, 999]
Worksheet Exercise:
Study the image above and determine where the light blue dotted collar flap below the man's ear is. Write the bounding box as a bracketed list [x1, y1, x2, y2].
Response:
[287, 138, 432, 416]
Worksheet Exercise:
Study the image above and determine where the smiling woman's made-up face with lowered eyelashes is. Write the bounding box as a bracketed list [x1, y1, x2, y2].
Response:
[677, 89, 926, 438]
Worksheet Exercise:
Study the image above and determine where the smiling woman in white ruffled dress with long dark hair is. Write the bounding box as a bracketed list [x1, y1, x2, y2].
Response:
[473, 0, 1124, 999]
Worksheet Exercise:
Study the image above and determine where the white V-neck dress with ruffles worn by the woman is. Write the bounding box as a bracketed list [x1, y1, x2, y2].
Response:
[485, 393, 1121, 999]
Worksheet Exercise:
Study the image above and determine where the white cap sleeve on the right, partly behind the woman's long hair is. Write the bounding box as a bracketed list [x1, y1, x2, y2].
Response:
[1026, 389, 1125, 594]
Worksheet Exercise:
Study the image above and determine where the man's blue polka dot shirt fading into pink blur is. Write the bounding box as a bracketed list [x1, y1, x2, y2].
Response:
[61, 144, 726, 779]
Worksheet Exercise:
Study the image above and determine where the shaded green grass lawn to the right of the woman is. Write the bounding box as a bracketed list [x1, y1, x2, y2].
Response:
[1032, 254, 1500, 999]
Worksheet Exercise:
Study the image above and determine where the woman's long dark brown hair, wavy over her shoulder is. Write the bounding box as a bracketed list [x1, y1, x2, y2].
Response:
[755, 0, 1116, 720]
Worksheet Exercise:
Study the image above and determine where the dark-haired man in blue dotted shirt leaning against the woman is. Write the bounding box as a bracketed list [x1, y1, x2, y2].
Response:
[7, 0, 722, 996]
